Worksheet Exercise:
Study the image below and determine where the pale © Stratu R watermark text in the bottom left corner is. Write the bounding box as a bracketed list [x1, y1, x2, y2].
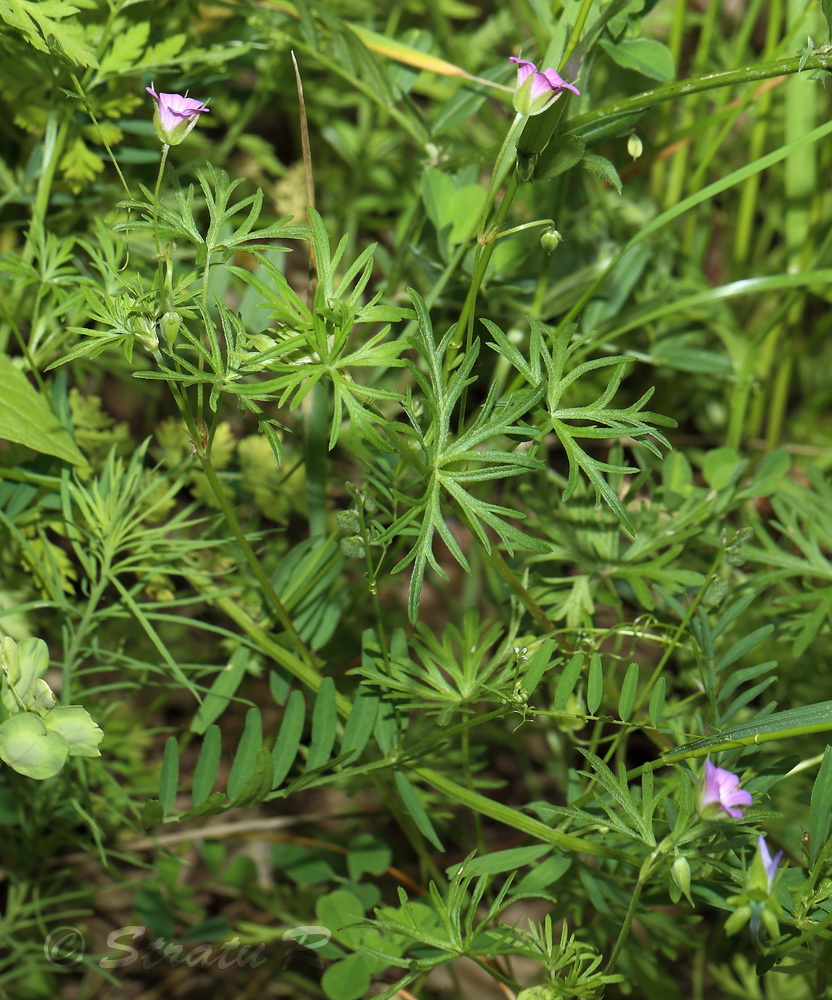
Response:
[43, 924, 331, 969]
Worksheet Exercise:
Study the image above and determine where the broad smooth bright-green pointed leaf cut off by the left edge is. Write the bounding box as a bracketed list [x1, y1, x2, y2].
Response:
[0, 354, 87, 466]
